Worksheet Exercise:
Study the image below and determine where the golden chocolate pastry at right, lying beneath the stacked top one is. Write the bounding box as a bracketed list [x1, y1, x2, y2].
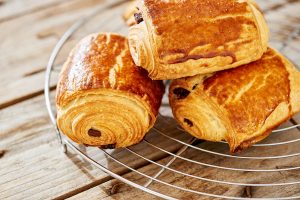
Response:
[169, 49, 300, 152]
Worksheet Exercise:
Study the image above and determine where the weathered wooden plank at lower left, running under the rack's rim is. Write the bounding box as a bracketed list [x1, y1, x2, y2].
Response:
[0, 91, 190, 199]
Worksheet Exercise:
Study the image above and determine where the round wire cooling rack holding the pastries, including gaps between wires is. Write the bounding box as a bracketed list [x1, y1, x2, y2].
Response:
[45, 0, 300, 199]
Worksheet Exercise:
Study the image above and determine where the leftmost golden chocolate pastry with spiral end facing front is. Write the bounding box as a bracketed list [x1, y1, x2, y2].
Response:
[56, 34, 164, 148]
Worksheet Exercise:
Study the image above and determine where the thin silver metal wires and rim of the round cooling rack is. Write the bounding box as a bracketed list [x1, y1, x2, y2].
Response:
[45, 1, 300, 199]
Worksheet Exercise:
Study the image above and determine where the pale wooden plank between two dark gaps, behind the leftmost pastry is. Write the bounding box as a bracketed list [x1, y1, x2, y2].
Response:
[0, 0, 126, 108]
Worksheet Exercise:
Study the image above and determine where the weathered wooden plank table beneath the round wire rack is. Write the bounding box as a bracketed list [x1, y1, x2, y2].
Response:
[0, 0, 300, 199]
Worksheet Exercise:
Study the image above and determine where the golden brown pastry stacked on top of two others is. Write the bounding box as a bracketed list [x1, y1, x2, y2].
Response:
[129, 0, 269, 79]
